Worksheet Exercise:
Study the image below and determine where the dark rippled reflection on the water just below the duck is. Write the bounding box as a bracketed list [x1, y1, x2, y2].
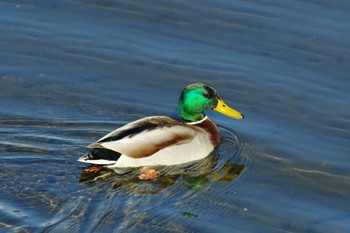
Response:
[79, 152, 245, 194]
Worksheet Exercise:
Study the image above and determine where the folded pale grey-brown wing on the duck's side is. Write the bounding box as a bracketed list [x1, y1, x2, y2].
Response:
[88, 116, 197, 158]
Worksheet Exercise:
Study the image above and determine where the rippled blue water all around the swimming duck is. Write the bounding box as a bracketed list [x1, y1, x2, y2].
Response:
[0, 0, 350, 232]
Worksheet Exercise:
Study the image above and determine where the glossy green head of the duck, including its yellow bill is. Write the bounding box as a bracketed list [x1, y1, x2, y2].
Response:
[179, 83, 244, 122]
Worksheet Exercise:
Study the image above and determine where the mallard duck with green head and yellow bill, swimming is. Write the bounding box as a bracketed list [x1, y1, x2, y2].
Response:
[79, 83, 244, 176]
